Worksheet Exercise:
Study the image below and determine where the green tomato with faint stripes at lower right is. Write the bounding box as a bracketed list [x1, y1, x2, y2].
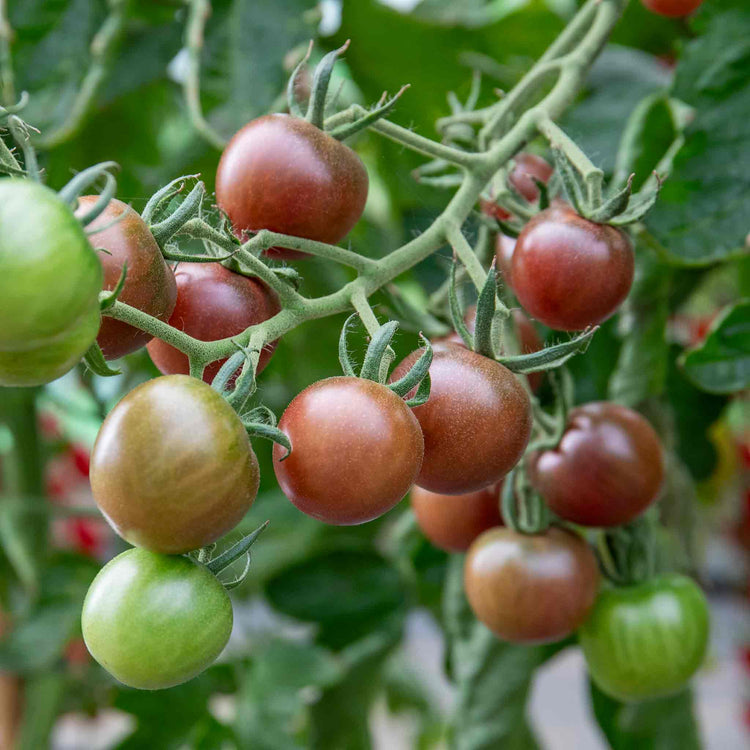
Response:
[578, 575, 709, 701]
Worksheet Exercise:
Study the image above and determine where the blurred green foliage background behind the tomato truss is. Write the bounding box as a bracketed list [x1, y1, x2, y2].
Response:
[0, 0, 750, 750]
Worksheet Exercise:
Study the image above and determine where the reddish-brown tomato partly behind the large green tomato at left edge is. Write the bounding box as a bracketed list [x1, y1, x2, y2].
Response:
[77, 195, 177, 359]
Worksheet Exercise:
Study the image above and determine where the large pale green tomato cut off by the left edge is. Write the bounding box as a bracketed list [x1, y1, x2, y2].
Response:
[0, 179, 102, 386]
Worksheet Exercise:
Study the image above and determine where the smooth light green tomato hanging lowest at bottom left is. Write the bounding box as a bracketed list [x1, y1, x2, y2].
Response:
[81, 549, 232, 690]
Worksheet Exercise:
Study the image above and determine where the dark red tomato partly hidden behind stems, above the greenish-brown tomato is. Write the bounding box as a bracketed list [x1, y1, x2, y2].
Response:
[148, 263, 281, 383]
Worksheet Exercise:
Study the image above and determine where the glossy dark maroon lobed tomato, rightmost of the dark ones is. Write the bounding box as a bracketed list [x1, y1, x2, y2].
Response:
[529, 401, 664, 526]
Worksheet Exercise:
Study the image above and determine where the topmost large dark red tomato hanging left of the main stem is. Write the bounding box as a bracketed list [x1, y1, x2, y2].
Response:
[216, 114, 368, 259]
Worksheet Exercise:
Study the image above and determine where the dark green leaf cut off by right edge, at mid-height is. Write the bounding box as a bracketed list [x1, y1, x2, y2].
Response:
[680, 299, 750, 393]
